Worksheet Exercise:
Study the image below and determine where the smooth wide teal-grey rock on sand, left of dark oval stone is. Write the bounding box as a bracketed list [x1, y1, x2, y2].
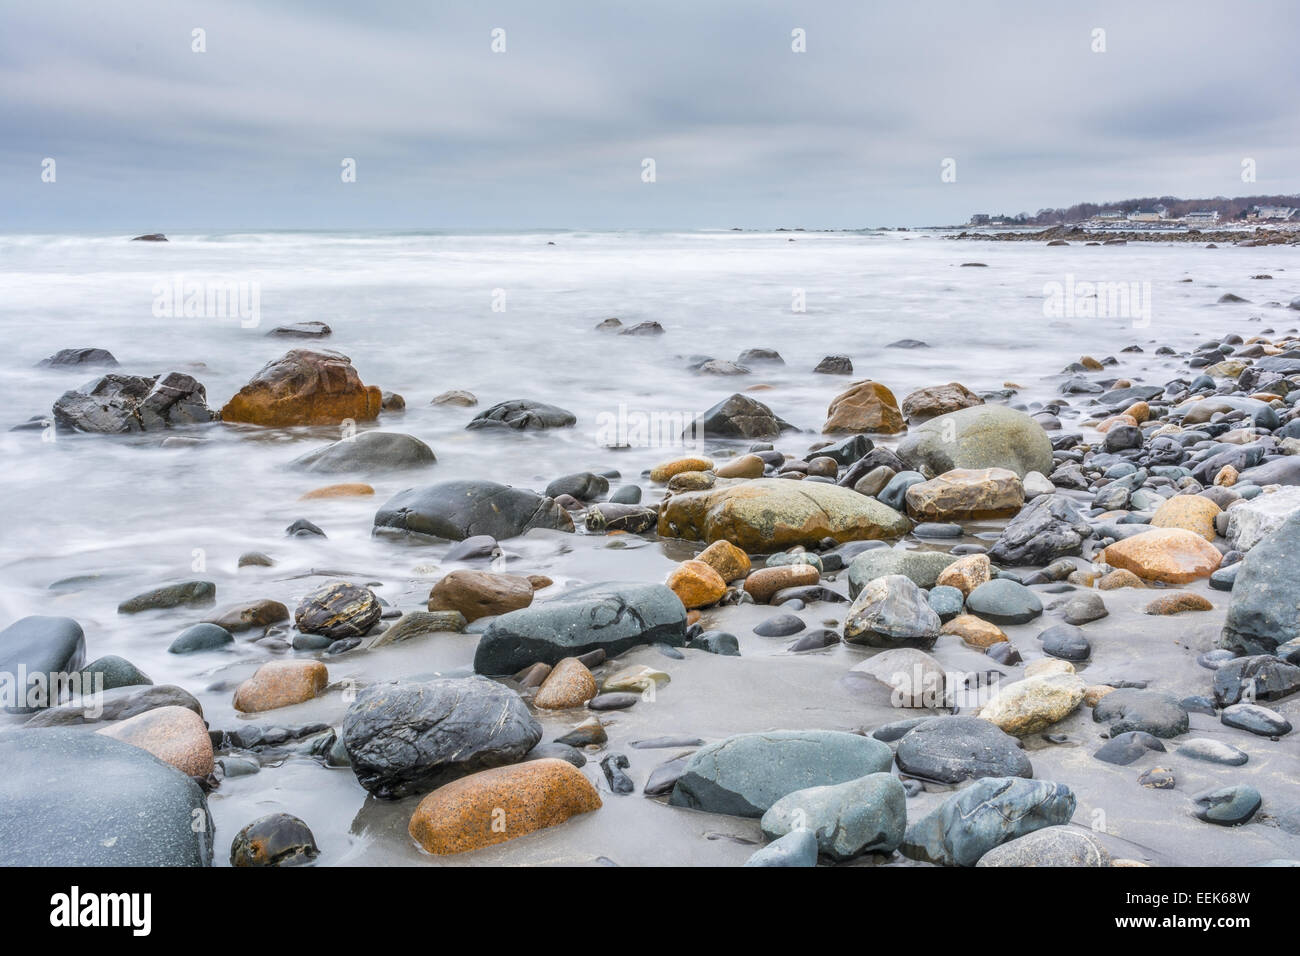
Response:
[668, 730, 893, 817]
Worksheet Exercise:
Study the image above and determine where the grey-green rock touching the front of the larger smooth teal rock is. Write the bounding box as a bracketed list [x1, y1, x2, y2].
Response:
[761, 773, 907, 861]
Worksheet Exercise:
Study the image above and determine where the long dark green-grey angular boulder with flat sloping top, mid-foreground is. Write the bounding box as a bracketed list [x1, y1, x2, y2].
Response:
[475, 584, 686, 674]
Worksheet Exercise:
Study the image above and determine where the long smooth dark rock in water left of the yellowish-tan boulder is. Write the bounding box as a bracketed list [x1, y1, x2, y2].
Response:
[374, 481, 573, 541]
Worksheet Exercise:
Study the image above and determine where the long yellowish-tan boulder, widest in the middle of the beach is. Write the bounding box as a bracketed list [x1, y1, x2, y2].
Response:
[659, 479, 911, 554]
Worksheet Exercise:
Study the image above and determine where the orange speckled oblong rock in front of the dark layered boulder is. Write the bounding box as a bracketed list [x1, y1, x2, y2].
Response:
[408, 759, 598, 856]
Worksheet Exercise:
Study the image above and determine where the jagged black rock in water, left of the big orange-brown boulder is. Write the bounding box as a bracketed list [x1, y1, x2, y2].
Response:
[52, 372, 216, 434]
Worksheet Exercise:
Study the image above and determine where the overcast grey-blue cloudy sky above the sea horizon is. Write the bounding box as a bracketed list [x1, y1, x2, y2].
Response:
[0, 0, 1300, 233]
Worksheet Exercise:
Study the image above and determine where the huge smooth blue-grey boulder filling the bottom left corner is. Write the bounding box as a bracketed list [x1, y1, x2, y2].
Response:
[0, 730, 215, 868]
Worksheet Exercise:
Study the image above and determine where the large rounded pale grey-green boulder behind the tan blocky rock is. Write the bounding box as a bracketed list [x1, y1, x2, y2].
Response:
[898, 405, 1052, 479]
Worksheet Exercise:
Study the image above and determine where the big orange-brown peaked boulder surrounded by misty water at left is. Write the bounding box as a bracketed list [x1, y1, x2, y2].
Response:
[221, 349, 384, 428]
